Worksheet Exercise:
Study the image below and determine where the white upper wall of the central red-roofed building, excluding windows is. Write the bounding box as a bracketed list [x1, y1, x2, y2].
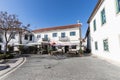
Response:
[34, 27, 80, 49]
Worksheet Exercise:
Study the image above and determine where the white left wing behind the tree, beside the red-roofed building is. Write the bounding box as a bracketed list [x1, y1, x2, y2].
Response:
[0, 31, 34, 51]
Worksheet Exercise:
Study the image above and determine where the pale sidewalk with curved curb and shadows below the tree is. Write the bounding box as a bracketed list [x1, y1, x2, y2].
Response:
[0, 57, 26, 79]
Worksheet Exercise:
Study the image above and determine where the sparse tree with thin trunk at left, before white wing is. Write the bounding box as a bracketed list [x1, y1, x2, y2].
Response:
[0, 12, 22, 54]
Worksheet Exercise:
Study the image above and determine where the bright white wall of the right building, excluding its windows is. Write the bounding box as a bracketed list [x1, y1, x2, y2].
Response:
[89, 0, 120, 61]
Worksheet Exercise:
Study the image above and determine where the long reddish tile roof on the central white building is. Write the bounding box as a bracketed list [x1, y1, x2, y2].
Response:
[32, 24, 81, 33]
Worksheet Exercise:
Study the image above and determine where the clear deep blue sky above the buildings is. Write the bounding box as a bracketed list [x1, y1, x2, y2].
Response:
[0, 0, 98, 37]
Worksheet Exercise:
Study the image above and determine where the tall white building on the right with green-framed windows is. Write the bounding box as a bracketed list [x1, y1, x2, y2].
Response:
[88, 0, 120, 61]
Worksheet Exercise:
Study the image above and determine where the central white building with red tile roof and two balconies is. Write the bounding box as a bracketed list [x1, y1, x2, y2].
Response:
[33, 24, 81, 50]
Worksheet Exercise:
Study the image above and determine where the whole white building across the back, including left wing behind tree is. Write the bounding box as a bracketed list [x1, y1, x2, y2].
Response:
[0, 24, 81, 53]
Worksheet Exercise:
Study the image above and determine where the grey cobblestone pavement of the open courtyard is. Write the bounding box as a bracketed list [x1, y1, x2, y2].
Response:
[3, 55, 120, 80]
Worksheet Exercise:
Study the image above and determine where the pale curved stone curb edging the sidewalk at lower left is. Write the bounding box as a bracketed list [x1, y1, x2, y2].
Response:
[0, 57, 26, 80]
